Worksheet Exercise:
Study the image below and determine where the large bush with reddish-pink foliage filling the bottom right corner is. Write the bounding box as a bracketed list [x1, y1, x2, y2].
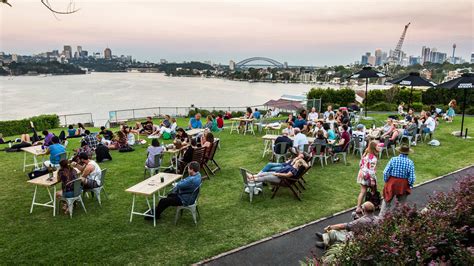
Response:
[323, 176, 474, 265]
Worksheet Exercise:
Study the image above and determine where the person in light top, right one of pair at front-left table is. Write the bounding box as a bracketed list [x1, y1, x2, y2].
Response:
[73, 153, 102, 189]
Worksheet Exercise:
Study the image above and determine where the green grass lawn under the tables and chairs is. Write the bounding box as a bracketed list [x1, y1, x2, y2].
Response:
[0, 115, 474, 265]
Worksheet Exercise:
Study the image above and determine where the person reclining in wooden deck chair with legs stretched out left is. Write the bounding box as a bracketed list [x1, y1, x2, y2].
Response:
[247, 158, 309, 183]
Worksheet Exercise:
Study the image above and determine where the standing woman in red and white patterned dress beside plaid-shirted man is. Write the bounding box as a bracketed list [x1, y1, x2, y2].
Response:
[356, 141, 378, 213]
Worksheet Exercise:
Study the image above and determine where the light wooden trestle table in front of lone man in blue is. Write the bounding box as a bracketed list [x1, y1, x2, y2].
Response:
[125, 173, 183, 226]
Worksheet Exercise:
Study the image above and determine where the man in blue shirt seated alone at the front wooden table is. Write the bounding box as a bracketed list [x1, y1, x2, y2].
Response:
[145, 161, 202, 220]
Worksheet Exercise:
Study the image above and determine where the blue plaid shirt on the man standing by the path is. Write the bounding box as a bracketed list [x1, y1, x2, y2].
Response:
[383, 154, 416, 188]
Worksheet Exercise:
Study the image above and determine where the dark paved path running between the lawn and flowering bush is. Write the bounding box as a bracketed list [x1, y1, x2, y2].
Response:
[199, 165, 474, 265]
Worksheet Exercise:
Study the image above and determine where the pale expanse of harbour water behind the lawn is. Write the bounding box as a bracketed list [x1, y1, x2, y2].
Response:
[0, 73, 314, 120]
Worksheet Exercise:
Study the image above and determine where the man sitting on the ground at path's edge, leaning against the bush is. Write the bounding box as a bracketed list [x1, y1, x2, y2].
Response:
[316, 201, 377, 249]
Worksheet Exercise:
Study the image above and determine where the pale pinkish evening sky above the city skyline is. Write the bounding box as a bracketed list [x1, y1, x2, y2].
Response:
[0, 0, 474, 66]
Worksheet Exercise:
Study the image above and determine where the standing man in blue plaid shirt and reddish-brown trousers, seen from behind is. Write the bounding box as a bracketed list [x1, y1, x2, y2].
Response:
[380, 144, 416, 216]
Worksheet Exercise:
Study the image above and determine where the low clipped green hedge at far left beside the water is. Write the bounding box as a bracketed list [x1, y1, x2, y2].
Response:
[0, 115, 59, 137]
